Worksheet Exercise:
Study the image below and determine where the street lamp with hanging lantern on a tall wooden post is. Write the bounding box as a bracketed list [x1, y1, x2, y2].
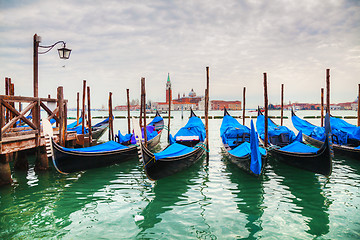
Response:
[34, 34, 71, 97]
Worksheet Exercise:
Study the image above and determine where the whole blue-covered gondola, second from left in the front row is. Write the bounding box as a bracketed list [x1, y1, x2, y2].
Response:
[140, 110, 206, 180]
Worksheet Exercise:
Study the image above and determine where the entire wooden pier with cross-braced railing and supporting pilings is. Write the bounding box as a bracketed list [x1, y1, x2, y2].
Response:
[0, 78, 76, 185]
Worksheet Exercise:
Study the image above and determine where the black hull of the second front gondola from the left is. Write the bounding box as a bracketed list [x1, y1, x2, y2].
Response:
[142, 142, 205, 180]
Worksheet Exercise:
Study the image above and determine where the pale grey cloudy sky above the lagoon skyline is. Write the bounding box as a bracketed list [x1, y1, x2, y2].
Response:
[0, 0, 360, 107]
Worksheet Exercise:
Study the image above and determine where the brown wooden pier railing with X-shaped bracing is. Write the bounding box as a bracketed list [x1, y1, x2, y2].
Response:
[0, 87, 67, 146]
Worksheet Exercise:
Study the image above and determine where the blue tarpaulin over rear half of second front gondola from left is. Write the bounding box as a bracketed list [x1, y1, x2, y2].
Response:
[174, 116, 206, 142]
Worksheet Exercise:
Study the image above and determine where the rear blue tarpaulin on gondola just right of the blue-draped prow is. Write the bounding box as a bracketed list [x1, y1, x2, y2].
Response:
[256, 115, 296, 142]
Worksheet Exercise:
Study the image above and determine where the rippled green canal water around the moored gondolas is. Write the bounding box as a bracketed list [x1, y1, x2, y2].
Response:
[0, 112, 360, 239]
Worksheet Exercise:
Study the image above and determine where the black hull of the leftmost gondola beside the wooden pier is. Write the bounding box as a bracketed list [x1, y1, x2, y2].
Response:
[53, 142, 138, 174]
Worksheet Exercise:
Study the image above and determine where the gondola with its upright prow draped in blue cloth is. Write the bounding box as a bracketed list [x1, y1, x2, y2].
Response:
[220, 108, 266, 176]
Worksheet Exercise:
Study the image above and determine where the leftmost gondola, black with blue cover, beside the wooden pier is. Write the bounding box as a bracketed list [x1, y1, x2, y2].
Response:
[44, 120, 138, 174]
